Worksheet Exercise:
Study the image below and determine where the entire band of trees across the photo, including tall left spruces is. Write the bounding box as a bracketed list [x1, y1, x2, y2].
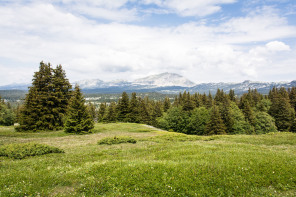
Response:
[0, 62, 296, 135]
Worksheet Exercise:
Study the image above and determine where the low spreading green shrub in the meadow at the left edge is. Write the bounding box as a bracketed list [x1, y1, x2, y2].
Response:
[0, 143, 64, 159]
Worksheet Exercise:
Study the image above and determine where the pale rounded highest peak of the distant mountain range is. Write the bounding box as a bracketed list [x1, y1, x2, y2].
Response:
[133, 72, 196, 87]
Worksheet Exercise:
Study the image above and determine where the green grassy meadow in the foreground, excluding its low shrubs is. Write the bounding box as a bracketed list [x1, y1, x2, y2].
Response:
[0, 123, 296, 196]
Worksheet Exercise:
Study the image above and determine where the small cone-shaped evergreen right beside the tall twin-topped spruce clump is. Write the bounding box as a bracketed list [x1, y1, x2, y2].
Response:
[65, 85, 94, 134]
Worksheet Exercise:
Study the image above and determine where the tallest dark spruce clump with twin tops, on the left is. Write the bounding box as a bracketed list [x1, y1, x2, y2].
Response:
[17, 62, 71, 131]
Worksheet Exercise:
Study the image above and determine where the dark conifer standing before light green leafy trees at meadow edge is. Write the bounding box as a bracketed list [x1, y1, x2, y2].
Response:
[205, 105, 226, 135]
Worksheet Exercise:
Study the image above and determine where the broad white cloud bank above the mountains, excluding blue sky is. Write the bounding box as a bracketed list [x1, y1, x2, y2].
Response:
[0, 0, 296, 85]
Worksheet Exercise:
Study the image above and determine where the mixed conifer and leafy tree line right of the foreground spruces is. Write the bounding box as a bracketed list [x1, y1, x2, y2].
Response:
[96, 87, 296, 135]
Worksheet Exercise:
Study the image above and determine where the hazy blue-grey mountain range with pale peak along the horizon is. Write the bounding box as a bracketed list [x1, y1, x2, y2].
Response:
[0, 73, 296, 94]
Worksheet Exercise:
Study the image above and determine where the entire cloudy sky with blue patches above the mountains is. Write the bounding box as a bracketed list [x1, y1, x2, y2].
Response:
[0, 0, 296, 85]
